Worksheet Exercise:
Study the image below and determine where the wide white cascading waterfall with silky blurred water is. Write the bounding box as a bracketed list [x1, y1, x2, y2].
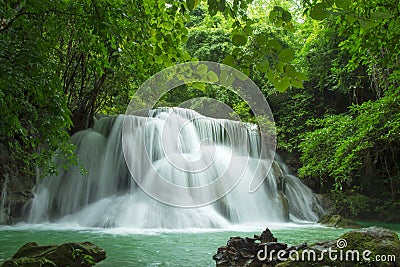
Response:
[29, 108, 322, 228]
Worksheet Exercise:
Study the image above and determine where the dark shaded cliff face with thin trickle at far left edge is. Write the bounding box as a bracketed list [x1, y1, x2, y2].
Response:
[0, 145, 35, 224]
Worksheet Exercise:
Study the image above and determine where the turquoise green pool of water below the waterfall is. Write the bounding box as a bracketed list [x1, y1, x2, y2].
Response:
[0, 224, 356, 267]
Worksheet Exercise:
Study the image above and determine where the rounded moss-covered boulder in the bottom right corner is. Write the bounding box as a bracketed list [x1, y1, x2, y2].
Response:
[276, 226, 400, 267]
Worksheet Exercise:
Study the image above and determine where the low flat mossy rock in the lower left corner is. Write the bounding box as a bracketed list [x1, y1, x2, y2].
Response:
[2, 242, 106, 267]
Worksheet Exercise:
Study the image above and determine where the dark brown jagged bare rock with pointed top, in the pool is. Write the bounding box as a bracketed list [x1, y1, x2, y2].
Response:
[213, 228, 307, 267]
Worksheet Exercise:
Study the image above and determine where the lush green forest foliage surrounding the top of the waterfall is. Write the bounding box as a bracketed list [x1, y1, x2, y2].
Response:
[0, 0, 400, 221]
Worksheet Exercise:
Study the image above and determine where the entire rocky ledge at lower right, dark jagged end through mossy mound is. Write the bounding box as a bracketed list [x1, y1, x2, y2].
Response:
[213, 227, 400, 267]
